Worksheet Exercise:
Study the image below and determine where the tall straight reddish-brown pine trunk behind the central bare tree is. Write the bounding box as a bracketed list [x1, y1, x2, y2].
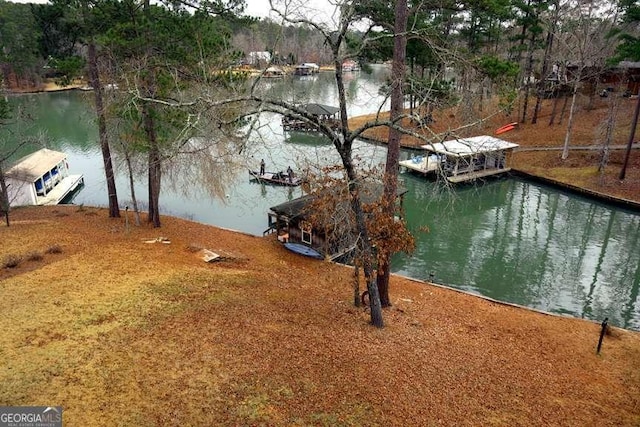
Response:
[377, 0, 408, 307]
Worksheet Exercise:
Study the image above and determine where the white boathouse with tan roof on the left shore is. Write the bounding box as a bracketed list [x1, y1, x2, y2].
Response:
[5, 148, 84, 206]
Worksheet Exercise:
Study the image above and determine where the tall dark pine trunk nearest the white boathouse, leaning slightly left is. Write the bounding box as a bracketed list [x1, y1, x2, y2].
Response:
[88, 40, 120, 218]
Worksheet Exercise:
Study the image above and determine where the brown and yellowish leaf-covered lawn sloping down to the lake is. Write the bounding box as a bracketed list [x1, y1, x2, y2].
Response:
[0, 206, 640, 426]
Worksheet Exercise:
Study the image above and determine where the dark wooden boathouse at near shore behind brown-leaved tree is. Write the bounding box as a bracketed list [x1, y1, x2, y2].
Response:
[264, 182, 407, 261]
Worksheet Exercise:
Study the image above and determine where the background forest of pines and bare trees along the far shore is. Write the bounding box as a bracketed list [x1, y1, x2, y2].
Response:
[0, 0, 640, 102]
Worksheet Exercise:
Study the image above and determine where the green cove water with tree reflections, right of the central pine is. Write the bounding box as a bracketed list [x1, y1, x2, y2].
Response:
[393, 174, 640, 329]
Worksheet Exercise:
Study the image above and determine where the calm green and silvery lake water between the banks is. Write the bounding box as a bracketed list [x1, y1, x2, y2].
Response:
[9, 67, 640, 330]
